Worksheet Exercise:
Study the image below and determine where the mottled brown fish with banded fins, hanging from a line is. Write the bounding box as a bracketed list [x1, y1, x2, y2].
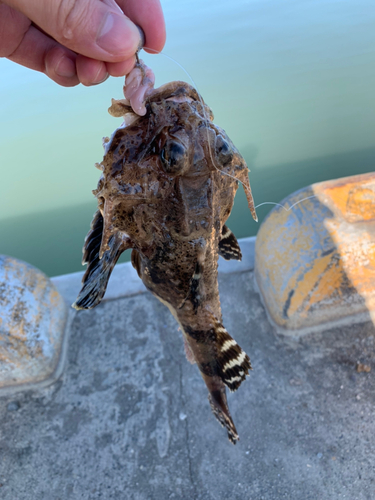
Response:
[73, 72, 257, 444]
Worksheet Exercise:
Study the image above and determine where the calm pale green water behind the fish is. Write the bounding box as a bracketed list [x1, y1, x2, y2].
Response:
[0, 0, 375, 275]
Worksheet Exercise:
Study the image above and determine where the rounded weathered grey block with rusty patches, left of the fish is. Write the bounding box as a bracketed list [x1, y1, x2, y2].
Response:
[0, 255, 68, 391]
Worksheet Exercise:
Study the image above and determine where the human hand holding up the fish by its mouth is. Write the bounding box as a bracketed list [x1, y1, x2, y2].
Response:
[0, 0, 165, 87]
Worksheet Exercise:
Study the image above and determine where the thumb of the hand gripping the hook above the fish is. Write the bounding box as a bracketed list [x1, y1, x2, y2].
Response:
[6, 0, 141, 62]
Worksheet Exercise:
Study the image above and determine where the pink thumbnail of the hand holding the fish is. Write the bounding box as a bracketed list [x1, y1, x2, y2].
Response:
[96, 12, 140, 57]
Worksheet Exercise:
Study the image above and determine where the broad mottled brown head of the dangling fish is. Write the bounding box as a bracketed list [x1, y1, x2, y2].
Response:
[94, 82, 256, 254]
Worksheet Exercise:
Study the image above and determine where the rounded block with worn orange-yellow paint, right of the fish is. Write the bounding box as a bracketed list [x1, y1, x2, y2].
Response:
[255, 173, 375, 334]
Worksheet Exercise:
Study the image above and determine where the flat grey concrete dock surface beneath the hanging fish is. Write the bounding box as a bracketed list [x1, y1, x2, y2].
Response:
[0, 243, 375, 500]
